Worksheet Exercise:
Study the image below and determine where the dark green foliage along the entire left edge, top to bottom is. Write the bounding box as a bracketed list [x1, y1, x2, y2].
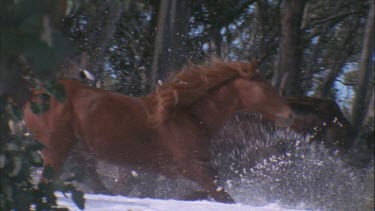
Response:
[0, 0, 84, 211]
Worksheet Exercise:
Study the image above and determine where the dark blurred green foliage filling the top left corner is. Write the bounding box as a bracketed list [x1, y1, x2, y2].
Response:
[0, 0, 71, 79]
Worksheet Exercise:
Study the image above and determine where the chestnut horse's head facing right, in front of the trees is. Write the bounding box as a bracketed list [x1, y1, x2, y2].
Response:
[233, 64, 294, 126]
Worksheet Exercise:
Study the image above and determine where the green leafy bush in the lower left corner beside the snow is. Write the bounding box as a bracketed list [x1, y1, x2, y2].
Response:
[0, 102, 85, 210]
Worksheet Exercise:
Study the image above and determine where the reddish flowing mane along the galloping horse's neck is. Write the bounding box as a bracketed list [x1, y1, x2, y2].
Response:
[149, 59, 257, 126]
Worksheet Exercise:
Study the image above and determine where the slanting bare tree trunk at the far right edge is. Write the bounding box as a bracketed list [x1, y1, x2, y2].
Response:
[352, 1, 374, 142]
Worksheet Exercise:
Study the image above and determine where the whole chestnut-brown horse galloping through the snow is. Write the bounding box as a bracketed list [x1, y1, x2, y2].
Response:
[24, 61, 292, 202]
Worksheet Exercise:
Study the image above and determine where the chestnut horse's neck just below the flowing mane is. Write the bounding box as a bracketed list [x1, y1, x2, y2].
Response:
[191, 82, 239, 135]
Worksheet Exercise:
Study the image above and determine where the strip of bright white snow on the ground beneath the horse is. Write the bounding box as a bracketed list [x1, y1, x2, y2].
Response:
[56, 193, 304, 211]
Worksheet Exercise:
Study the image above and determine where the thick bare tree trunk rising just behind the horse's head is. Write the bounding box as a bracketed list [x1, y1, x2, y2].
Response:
[273, 0, 306, 95]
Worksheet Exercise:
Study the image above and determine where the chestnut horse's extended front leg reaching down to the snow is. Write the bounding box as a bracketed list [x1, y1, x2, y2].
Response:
[185, 162, 235, 203]
